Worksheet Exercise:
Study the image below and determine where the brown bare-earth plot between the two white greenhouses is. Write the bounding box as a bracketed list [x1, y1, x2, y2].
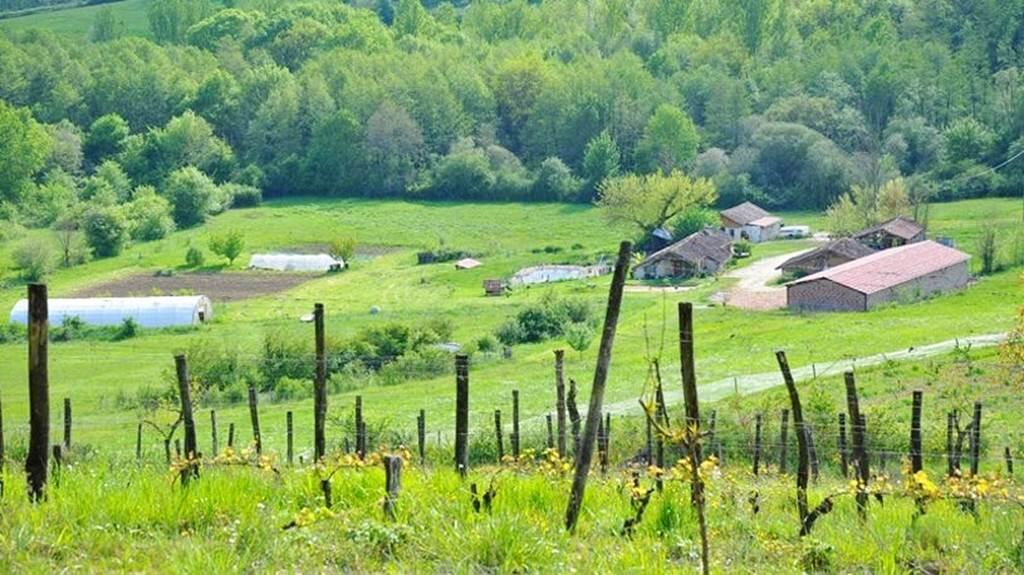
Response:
[71, 271, 319, 302]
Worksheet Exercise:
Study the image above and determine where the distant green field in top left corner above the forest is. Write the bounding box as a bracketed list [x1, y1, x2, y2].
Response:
[0, 0, 150, 40]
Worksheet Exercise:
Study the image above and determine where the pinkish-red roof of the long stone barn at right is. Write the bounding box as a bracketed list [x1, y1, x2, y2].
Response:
[790, 240, 971, 294]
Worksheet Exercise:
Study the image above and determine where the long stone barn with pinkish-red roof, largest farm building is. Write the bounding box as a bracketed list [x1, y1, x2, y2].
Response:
[786, 240, 971, 311]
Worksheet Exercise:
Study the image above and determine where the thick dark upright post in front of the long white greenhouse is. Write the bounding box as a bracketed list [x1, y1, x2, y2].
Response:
[25, 283, 50, 502]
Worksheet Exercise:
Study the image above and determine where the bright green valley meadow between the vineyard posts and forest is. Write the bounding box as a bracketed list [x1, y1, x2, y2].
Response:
[0, 195, 1021, 450]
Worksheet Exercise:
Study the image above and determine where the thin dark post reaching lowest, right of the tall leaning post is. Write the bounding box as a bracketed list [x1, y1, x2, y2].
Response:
[679, 302, 711, 575]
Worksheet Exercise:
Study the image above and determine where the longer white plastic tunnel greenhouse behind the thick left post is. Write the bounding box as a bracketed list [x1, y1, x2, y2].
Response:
[10, 296, 213, 327]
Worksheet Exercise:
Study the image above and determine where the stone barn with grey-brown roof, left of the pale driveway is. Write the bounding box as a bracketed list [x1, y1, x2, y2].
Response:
[633, 229, 732, 279]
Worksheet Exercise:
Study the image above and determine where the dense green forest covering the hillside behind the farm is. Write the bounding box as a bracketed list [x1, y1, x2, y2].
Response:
[0, 0, 1024, 241]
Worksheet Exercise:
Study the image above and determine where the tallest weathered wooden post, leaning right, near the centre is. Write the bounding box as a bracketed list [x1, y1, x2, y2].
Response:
[565, 241, 633, 532]
